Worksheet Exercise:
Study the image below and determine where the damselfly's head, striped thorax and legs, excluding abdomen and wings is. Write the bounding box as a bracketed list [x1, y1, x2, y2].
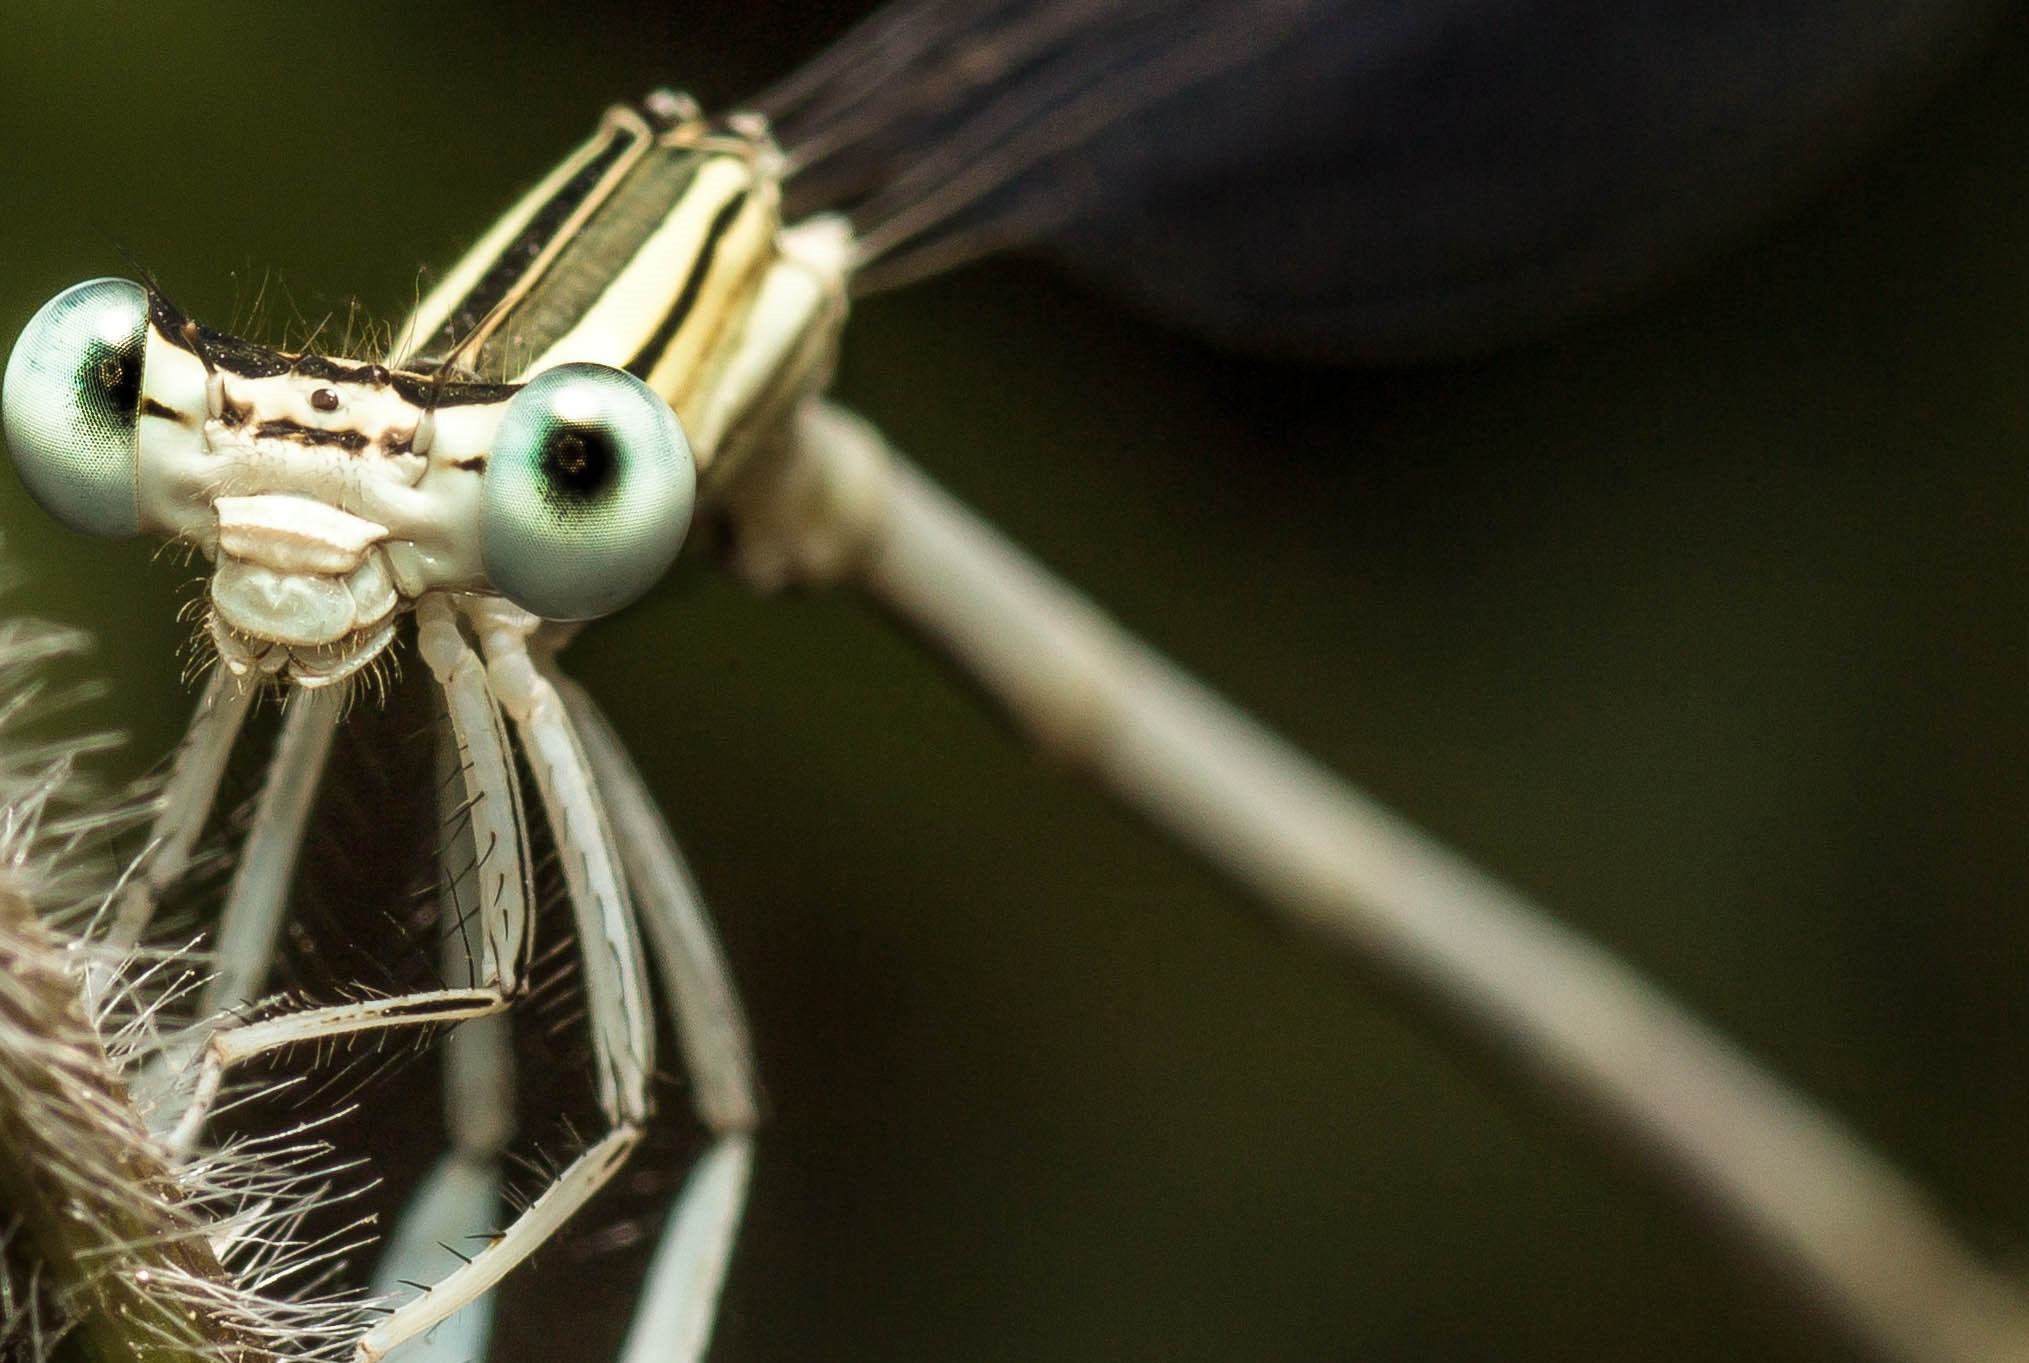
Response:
[6, 95, 807, 1338]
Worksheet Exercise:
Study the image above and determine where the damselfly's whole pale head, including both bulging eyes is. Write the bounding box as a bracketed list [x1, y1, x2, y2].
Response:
[0, 280, 696, 686]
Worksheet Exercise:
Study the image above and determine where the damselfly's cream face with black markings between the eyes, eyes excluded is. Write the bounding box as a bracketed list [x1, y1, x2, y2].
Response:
[136, 325, 505, 686]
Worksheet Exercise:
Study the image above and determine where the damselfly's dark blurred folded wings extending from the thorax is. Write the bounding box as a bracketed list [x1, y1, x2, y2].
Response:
[759, 0, 2001, 357]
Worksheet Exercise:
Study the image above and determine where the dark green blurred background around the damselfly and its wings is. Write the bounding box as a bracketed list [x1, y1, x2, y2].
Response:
[0, 0, 2029, 1363]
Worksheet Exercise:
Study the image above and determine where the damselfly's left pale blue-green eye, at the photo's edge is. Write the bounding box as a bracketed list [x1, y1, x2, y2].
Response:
[0, 280, 148, 537]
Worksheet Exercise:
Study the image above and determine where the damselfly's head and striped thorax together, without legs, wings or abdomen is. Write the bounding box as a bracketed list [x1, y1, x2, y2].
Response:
[4, 95, 850, 686]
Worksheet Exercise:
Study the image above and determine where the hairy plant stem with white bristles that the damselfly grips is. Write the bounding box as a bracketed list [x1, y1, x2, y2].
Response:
[0, 576, 371, 1363]
